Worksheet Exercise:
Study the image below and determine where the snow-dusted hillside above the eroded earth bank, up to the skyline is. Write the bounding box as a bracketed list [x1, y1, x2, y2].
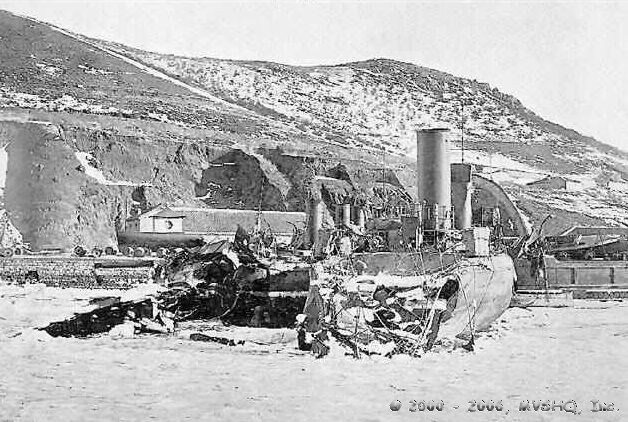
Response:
[0, 8, 628, 237]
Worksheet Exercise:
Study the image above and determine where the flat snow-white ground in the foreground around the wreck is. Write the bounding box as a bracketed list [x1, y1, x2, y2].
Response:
[0, 286, 628, 422]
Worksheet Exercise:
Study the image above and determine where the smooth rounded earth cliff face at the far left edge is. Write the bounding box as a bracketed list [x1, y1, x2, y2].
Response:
[0, 122, 120, 250]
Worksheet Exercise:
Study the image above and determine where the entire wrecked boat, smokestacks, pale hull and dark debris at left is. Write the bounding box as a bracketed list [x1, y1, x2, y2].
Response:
[43, 129, 517, 357]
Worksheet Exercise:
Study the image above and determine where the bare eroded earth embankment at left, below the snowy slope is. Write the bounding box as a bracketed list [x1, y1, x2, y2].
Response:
[0, 116, 296, 250]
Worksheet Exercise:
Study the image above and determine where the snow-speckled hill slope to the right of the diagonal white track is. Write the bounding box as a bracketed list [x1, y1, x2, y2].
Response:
[89, 41, 628, 231]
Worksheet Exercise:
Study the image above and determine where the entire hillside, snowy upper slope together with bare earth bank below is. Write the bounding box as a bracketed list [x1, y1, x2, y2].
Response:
[0, 11, 628, 246]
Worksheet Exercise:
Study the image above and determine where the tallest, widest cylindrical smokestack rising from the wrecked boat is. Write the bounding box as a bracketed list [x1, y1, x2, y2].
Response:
[417, 129, 451, 229]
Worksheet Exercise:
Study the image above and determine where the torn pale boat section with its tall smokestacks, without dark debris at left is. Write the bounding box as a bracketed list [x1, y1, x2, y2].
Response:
[298, 129, 516, 356]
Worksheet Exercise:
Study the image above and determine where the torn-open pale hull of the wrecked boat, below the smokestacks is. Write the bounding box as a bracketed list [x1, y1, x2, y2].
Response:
[298, 253, 515, 357]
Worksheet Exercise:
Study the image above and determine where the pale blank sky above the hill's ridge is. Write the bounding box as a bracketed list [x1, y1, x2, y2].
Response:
[0, 0, 628, 150]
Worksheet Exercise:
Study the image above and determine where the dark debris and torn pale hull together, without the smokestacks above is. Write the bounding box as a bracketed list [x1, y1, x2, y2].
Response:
[43, 229, 514, 357]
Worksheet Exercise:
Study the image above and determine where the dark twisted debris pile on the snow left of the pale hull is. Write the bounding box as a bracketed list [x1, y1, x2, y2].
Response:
[43, 242, 309, 340]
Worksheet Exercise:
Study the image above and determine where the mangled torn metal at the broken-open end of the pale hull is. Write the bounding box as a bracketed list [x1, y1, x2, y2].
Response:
[297, 264, 459, 357]
